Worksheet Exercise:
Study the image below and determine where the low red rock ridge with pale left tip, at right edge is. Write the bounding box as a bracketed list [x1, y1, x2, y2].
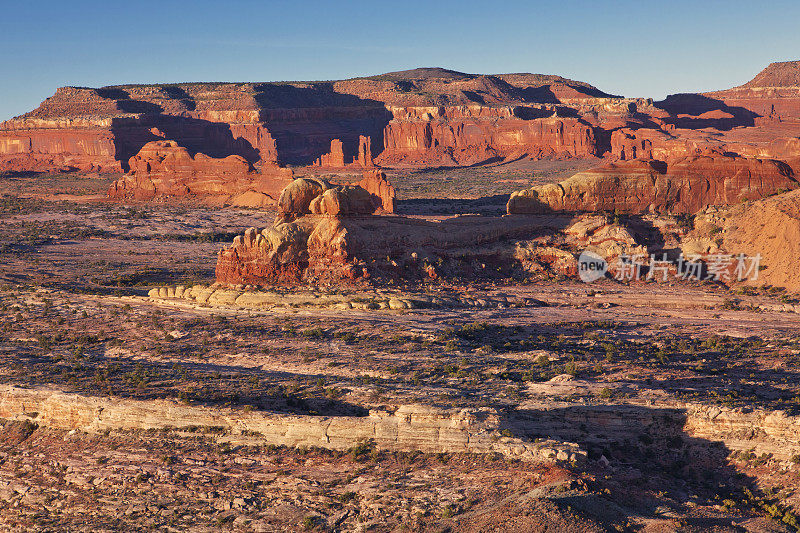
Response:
[507, 152, 798, 214]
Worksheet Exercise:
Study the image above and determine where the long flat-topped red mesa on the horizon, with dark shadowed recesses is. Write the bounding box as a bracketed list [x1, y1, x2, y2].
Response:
[0, 69, 629, 175]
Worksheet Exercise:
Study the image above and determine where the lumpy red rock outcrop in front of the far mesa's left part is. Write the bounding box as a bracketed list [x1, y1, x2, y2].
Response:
[108, 140, 292, 207]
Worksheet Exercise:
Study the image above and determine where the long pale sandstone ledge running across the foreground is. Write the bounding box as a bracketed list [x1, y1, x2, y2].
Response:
[6, 386, 800, 463]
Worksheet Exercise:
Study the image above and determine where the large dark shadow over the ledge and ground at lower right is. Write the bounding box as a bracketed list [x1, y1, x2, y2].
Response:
[502, 405, 781, 530]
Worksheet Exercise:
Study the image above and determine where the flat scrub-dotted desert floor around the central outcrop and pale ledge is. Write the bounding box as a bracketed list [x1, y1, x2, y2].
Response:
[0, 161, 800, 532]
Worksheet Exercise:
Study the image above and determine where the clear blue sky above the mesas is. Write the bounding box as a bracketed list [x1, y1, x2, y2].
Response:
[0, 0, 800, 120]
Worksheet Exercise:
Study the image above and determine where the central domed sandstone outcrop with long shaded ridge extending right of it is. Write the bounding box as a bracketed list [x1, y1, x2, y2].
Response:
[216, 175, 644, 286]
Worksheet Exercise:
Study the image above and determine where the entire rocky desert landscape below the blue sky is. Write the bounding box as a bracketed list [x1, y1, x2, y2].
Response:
[0, 62, 800, 532]
